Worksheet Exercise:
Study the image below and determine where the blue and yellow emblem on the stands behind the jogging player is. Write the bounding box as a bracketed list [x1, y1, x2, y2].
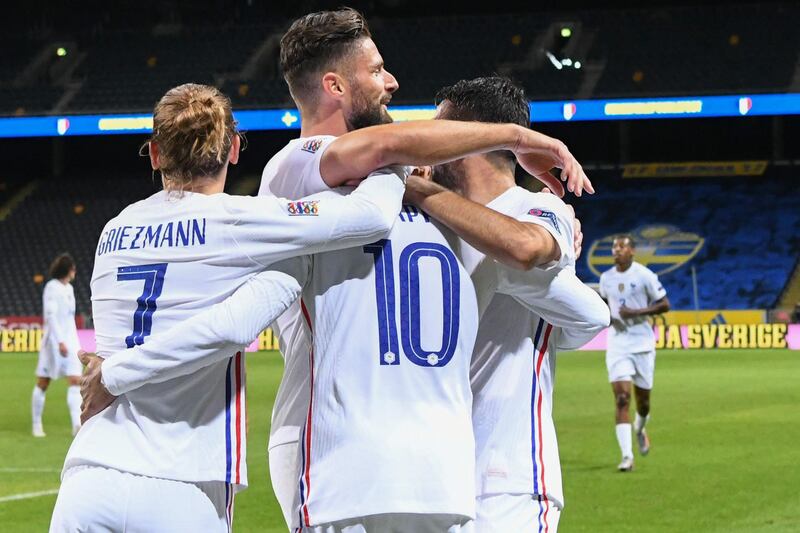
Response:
[586, 224, 705, 277]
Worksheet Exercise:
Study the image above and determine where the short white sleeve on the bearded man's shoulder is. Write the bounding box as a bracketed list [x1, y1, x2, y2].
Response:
[258, 135, 336, 198]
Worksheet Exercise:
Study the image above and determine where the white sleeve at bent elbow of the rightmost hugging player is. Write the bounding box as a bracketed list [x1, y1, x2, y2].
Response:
[500, 268, 611, 350]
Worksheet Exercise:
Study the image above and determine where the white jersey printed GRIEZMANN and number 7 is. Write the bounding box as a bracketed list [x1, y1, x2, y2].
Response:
[64, 172, 404, 486]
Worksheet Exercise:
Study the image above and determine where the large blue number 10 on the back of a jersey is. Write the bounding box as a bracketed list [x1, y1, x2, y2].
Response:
[364, 239, 461, 367]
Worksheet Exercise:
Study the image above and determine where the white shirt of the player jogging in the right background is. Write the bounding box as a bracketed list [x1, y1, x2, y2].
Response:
[600, 261, 667, 354]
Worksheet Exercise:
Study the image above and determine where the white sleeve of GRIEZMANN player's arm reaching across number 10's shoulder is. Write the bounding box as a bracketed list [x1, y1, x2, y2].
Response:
[228, 167, 407, 268]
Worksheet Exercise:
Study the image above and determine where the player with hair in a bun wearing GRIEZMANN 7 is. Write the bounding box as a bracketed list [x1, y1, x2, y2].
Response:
[51, 84, 404, 532]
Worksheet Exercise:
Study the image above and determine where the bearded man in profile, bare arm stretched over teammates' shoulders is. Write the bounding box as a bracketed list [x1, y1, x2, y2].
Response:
[260, 9, 585, 527]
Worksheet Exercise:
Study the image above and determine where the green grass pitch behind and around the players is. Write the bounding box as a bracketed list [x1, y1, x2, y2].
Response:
[0, 350, 800, 533]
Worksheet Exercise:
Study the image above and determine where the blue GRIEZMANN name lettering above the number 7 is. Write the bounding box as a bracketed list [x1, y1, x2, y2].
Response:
[97, 218, 206, 256]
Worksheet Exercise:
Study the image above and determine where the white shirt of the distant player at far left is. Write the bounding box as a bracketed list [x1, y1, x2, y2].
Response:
[42, 279, 80, 356]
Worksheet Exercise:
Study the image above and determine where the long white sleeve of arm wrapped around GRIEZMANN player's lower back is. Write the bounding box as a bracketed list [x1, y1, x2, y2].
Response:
[102, 266, 303, 396]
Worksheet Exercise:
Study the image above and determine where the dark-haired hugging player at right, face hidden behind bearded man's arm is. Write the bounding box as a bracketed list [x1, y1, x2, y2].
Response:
[404, 77, 609, 533]
